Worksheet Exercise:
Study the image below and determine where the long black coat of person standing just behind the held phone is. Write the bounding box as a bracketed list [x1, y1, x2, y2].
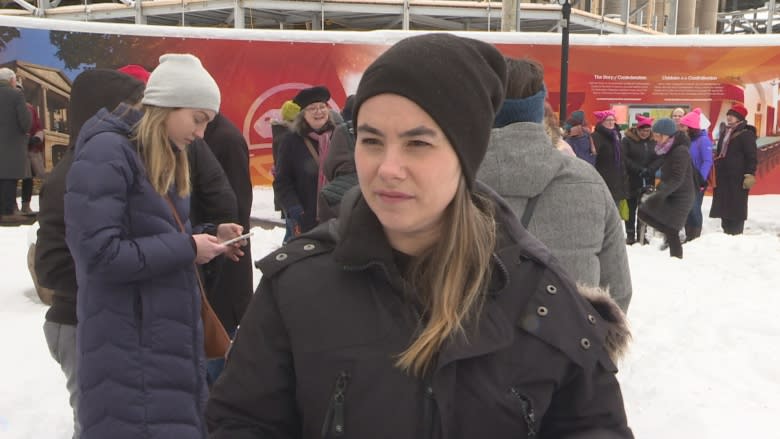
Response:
[203, 114, 254, 329]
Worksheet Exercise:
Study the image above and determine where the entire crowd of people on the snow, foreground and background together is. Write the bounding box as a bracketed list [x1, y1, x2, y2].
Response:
[0, 34, 756, 439]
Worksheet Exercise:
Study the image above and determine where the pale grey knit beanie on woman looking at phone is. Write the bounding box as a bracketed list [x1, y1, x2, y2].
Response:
[142, 53, 220, 112]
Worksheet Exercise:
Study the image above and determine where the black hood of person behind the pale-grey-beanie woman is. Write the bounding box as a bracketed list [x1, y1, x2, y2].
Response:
[68, 69, 145, 146]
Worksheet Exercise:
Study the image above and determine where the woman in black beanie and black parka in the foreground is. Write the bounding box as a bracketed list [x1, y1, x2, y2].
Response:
[206, 34, 632, 439]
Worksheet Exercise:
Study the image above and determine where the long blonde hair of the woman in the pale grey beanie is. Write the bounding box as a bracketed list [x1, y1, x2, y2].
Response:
[135, 105, 190, 197]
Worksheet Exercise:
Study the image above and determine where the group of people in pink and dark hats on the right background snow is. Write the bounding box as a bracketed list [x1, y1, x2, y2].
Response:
[564, 103, 757, 258]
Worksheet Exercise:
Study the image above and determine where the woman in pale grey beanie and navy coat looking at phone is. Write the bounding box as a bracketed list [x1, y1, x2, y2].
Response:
[65, 54, 242, 439]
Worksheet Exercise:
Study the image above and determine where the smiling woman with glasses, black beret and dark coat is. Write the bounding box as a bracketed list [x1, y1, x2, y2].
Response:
[274, 86, 335, 242]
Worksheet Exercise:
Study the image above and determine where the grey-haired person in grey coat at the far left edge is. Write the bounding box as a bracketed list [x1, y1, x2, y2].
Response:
[0, 68, 32, 223]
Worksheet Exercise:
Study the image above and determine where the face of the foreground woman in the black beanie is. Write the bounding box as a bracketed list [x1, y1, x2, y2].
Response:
[355, 94, 462, 255]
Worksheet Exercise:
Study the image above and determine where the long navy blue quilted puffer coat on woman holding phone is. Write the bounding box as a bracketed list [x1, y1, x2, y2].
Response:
[65, 106, 207, 439]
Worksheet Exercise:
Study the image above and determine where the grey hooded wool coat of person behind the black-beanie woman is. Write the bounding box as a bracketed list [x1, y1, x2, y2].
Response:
[477, 122, 632, 311]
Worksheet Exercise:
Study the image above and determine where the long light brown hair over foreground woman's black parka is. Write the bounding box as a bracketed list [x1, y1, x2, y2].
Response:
[396, 179, 496, 376]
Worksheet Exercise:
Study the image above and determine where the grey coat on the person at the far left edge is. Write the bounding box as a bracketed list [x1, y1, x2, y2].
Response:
[0, 81, 32, 180]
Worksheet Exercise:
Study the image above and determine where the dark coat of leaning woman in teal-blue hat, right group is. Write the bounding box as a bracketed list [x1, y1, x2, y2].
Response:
[639, 132, 696, 230]
